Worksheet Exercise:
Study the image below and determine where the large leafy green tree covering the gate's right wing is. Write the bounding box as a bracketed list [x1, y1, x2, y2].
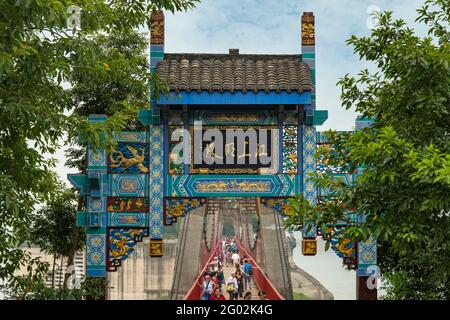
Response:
[288, 0, 450, 299]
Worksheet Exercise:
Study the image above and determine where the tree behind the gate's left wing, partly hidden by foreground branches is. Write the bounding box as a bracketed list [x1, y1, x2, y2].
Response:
[64, 31, 162, 286]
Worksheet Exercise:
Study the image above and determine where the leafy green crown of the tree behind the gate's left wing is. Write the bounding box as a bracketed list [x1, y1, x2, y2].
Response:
[66, 31, 168, 171]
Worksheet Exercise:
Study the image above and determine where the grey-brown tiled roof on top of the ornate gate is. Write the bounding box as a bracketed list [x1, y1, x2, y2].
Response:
[156, 49, 313, 93]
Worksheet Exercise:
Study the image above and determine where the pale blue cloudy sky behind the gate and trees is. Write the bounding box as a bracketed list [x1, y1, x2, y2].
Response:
[56, 0, 424, 299]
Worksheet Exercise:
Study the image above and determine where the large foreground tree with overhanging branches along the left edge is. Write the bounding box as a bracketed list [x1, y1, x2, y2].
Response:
[0, 0, 198, 296]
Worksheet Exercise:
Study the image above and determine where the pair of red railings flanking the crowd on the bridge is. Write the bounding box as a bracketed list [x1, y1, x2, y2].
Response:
[183, 242, 285, 300]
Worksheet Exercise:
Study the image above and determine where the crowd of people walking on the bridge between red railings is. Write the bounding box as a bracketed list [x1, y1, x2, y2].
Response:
[202, 238, 267, 300]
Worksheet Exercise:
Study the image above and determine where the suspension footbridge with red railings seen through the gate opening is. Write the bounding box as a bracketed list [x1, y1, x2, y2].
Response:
[171, 198, 292, 300]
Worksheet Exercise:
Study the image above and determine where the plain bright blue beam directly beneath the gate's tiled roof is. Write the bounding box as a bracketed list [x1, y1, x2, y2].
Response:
[158, 91, 311, 105]
